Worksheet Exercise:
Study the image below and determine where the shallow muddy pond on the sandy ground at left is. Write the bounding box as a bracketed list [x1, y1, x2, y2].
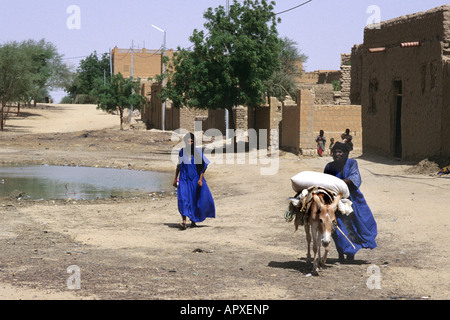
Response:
[0, 165, 173, 200]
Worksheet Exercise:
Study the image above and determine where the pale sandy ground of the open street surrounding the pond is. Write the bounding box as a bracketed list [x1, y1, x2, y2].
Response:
[0, 105, 450, 300]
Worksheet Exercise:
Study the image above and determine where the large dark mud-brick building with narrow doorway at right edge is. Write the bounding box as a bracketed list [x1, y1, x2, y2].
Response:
[350, 5, 450, 160]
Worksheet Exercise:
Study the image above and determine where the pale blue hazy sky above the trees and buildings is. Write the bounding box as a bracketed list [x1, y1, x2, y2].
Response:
[0, 0, 449, 102]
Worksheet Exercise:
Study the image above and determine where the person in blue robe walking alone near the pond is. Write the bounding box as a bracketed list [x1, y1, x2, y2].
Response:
[173, 133, 216, 230]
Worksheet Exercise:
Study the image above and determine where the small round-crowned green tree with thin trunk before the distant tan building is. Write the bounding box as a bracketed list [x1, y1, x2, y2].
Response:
[91, 72, 145, 130]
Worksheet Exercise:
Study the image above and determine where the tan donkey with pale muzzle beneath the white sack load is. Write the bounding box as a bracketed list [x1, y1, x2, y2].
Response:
[304, 191, 342, 275]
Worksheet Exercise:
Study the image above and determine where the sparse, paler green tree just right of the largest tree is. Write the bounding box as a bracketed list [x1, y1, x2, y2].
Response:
[265, 37, 308, 101]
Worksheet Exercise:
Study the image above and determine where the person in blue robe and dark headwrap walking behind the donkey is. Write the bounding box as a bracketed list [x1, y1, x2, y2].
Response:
[324, 142, 378, 261]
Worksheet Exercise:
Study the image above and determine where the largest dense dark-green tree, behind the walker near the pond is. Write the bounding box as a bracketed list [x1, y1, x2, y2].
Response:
[163, 0, 280, 124]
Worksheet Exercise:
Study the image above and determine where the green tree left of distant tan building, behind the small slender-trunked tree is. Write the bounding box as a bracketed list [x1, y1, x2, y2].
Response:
[66, 51, 111, 101]
